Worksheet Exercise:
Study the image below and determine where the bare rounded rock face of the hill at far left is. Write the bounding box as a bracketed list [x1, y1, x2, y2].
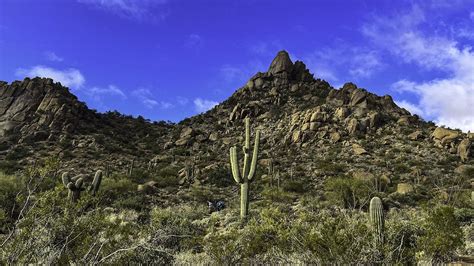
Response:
[0, 78, 95, 142]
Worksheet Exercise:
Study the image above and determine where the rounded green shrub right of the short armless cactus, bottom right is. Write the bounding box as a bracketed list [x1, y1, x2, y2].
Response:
[419, 206, 463, 262]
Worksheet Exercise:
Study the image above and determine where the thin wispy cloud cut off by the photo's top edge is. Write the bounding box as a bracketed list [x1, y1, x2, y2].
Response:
[77, 0, 167, 21]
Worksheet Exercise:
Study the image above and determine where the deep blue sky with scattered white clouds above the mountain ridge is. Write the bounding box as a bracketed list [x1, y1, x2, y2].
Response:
[0, 0, 474, 131]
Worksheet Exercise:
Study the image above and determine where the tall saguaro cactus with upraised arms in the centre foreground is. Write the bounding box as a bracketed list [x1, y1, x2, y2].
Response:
[230, 117, 260, 219]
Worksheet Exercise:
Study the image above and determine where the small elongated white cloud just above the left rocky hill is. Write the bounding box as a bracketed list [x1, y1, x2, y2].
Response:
[15, 65, 85, 89]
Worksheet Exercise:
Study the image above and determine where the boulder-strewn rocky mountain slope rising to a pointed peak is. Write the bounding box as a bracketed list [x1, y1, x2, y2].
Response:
[0, 51, 474, 195]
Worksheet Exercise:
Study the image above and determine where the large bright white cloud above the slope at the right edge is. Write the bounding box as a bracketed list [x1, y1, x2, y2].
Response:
[363, 5, 474, 131]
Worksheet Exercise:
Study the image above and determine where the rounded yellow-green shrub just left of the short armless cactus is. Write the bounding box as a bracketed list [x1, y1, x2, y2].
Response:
[324, 177, 375, 208]
